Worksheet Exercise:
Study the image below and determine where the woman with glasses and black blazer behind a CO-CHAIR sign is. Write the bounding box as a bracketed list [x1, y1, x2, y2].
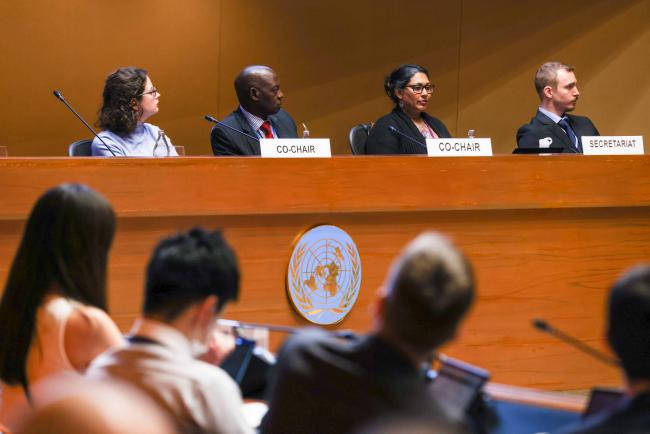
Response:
[366, 64, 451, 154]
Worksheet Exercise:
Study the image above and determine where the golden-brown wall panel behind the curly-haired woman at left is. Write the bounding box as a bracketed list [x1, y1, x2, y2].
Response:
[0, 0, 219, 156]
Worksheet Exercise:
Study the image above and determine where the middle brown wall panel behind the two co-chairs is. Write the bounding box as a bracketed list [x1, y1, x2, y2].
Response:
[219, 0, 460, 154]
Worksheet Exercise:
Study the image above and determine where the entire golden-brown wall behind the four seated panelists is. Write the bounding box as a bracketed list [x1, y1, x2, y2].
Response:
[0, 0, 650, 156]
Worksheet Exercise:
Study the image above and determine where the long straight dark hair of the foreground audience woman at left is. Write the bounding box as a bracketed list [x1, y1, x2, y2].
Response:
[0, 184, 115, 398]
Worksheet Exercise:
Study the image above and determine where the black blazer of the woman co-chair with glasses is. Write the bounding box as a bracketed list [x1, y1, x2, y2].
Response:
[366, 107, 451, 154]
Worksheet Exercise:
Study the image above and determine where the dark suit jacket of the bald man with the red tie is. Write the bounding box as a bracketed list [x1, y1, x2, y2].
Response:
[210, 108, 298, 155]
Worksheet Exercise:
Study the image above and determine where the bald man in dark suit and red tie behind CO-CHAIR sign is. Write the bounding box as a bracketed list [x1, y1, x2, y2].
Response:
[210, 65, 298, 155]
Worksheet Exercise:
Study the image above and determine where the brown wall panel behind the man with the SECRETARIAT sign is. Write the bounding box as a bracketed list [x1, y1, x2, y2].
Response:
[458, 0, 650, 153]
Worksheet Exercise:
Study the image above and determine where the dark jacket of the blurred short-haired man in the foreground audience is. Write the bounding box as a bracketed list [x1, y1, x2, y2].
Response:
[261, 329, 462, 434]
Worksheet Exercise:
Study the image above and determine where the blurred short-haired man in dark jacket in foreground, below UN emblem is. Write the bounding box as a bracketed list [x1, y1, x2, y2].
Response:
[262, 233, 474, 434]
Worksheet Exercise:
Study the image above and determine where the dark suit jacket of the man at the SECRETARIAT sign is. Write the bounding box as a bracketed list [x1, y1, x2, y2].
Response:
[517, 110, 600, 154]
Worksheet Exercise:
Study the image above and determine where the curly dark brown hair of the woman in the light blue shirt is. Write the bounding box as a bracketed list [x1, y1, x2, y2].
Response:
[97, 67, 147, 136]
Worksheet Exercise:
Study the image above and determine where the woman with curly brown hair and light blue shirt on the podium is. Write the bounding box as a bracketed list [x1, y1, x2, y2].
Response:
[92, 67, 178, 157]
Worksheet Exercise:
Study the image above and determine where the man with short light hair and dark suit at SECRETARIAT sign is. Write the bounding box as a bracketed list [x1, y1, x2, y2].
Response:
[517, 62, 600, 154]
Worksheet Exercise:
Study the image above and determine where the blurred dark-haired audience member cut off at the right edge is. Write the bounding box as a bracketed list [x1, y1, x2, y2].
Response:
[561, 265, 650, 434]
